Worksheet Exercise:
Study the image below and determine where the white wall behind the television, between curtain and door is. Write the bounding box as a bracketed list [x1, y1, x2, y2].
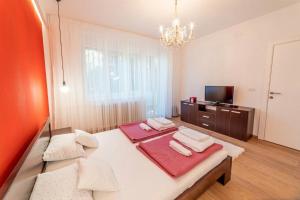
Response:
[181, 3, 300, 135]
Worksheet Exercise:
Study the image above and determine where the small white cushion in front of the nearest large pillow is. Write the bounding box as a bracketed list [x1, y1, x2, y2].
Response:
[78, 158, 119, 192]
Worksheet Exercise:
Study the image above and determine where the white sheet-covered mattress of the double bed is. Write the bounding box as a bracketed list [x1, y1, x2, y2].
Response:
[46, 129, 228, 200]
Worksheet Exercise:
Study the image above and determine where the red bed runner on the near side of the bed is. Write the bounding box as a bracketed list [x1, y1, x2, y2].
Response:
[137, 134, 223, 177]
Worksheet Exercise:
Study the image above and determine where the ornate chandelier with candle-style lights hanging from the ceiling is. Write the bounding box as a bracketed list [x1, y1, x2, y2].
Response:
[159, 0, 194, 47]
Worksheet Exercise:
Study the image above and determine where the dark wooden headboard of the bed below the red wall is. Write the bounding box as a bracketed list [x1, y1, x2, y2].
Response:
[0, 118, 51, 200]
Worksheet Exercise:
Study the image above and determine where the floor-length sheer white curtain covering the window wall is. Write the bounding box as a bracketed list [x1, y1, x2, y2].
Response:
[49, 16, 172, 132]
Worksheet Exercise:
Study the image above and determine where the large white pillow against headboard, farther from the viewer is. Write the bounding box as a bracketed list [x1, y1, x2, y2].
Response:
[43, 133, 85, 161]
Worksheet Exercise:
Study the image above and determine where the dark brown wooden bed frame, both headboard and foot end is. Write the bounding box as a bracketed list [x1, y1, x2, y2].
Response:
[0, 120, 232, 200]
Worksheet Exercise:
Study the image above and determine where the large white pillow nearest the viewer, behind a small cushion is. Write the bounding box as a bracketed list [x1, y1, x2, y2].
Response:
[30, 164, 93, 200]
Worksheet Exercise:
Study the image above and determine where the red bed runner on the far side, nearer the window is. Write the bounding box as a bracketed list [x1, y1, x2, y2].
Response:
[119, 122, 178, 143]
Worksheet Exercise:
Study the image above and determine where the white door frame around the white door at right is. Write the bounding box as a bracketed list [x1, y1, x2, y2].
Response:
[258, 36, 300, 140]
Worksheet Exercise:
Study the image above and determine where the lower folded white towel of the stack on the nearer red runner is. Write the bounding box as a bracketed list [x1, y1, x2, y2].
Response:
[173, 132, 215, 152]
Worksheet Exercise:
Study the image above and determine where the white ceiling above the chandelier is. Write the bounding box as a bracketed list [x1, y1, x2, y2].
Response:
[38, 0, 300, 37]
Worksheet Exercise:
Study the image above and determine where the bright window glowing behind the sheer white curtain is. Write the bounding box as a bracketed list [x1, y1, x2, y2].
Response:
[84, 48, 167, 116]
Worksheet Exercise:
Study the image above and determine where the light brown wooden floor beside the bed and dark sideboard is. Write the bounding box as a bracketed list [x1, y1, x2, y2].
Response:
[174, 118, 300, 200]
